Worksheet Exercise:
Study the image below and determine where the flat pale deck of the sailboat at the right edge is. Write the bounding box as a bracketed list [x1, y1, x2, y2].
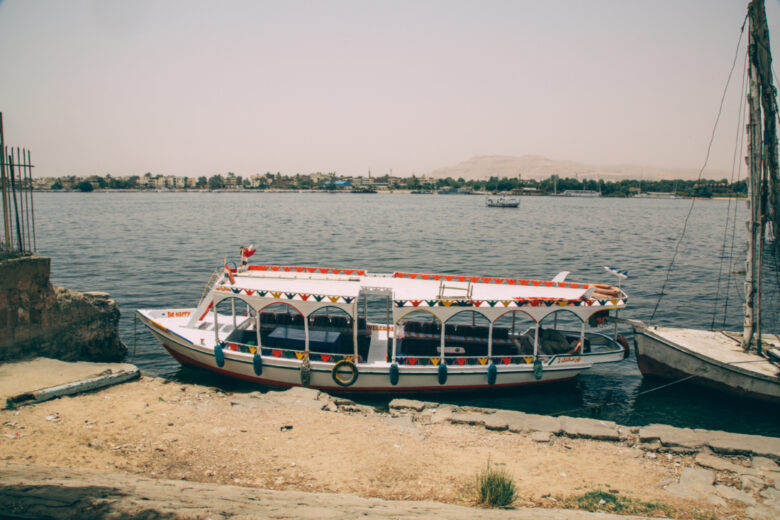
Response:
[650, 327, 780, 377]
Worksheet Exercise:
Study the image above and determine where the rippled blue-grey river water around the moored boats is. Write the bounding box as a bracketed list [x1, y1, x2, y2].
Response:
[35, 192, 780, 436]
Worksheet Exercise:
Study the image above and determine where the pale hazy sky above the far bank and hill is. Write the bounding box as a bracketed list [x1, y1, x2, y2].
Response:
[0, 0, 780, 176]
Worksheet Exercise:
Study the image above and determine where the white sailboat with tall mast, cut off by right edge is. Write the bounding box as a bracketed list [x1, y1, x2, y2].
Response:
[628, 0, 780, 403]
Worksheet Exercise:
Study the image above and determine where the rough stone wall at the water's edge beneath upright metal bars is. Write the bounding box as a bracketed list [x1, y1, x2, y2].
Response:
[0, 256, 127, 361]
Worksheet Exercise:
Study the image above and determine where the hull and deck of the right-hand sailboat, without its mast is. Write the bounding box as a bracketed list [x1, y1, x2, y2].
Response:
[634, 324, 780, 404]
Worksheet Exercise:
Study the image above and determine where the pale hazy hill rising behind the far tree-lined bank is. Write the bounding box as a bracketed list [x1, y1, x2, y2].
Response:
[427, 155, 728, 181]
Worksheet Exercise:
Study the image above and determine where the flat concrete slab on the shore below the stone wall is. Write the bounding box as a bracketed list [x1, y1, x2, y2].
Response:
[0, 358, 141, 407]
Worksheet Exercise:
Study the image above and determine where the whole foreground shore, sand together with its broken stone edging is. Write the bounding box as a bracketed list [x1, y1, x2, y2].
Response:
[0, 377, 780, 520]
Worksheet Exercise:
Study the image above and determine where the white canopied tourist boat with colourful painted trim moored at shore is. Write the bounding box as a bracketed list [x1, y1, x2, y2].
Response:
[137, 247, 628, 393]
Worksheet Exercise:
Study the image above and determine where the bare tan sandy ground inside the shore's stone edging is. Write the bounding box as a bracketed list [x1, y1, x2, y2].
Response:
[0, 377, 739, 518]
